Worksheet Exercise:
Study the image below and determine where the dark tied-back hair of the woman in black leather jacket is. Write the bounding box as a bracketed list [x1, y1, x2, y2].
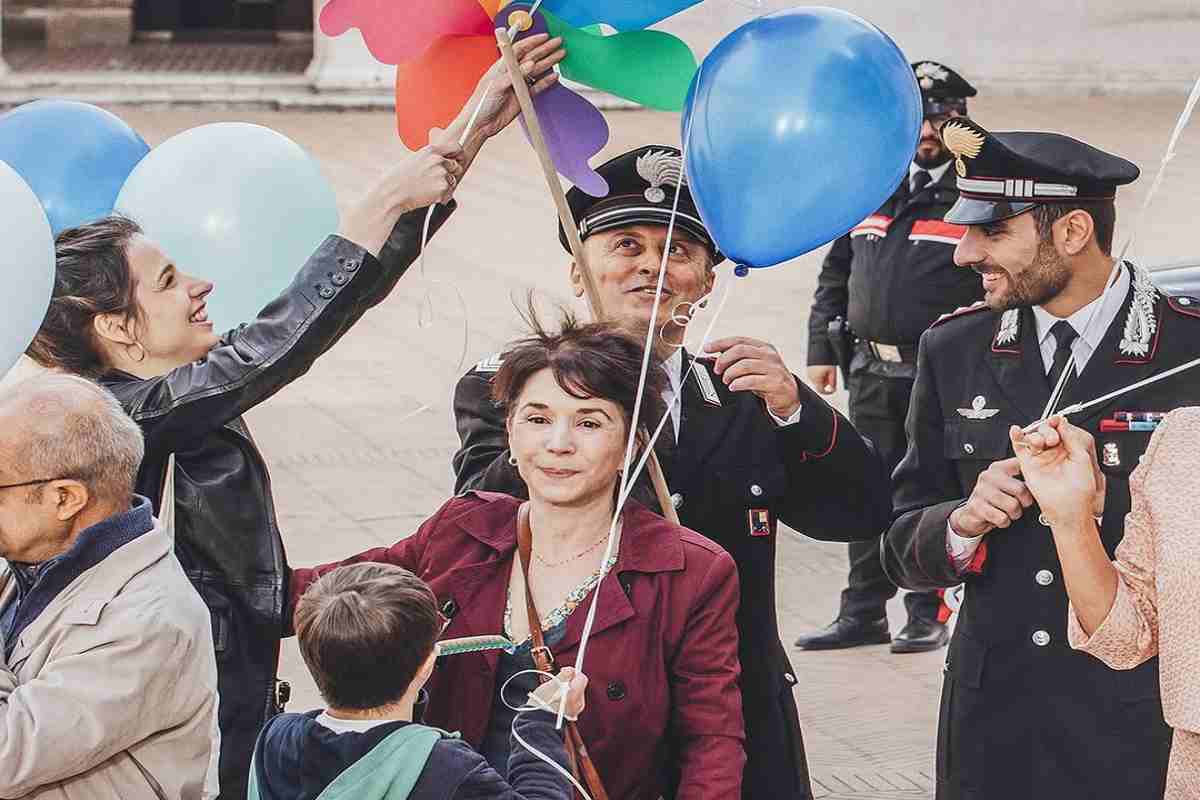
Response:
[26, 216, 142, 378]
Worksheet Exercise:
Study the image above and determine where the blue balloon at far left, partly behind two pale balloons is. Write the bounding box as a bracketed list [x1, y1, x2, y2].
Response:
[0, 100, 150, 234]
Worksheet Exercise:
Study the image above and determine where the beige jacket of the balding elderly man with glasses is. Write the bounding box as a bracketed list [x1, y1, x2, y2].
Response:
[0, 527, 218, 800]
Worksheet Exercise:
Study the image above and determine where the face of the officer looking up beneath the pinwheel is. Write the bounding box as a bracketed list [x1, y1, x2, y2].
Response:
[571, 225, 713, 327]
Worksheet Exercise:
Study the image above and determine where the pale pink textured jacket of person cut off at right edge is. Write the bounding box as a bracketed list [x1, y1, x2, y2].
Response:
[1068, 408, 1200, 733]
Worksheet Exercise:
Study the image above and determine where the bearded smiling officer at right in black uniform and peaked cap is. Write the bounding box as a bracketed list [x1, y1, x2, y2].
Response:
[883, 118, 1200, 800]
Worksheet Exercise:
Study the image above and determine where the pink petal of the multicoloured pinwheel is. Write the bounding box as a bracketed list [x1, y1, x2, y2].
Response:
[320, 0, 493, 64]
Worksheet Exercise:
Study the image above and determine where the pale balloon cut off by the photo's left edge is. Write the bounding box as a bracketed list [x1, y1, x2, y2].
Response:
[0, 162, 54, 378]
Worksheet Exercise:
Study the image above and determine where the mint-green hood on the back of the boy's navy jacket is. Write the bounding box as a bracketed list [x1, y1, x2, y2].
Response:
[314, 724, 451, 800]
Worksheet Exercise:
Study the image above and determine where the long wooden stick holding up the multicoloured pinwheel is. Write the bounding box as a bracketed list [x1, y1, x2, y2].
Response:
[496, 28, 679, 525]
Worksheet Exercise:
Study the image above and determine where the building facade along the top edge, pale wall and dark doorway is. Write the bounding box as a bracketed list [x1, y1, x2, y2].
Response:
[0, 0, 1200, 94]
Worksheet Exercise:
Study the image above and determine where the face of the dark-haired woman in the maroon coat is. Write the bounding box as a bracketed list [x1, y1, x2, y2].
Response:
[509, 368, 625, 506]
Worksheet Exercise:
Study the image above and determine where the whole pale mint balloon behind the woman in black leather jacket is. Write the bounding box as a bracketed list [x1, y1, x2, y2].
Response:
[116, 122, 337, 332]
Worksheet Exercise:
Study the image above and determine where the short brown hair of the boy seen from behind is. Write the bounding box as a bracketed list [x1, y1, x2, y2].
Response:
[295, 564, 442, 709]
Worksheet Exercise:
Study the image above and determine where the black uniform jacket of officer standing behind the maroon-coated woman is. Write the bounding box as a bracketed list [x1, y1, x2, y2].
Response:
[454, 354, 890, 799]
